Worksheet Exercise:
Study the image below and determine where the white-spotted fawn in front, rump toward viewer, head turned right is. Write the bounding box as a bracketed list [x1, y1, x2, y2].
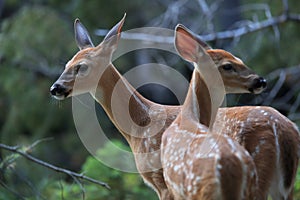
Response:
[161, 24, 264, 200]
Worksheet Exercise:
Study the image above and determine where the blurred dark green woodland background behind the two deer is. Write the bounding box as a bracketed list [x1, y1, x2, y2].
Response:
[0, 0, 300, 199]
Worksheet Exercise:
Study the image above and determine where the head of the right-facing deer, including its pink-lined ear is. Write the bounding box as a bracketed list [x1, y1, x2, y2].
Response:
[175, 24, 267, 94]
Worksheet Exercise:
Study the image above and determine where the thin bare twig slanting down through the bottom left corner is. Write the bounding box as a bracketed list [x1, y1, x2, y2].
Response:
[0, 144, 110, 189]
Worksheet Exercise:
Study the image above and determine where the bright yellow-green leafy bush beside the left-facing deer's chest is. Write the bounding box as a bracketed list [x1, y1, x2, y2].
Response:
[78, 140, 156, 200]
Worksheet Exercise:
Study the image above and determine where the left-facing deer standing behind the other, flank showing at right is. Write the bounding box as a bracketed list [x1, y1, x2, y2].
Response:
[50, 16, 299, 199]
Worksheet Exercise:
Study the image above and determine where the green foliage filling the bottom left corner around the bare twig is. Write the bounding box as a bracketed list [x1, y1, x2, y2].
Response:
[0, 140, 156, 200]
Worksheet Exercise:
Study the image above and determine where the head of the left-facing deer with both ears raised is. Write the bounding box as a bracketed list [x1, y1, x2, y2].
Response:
[50, 14, 126, 100]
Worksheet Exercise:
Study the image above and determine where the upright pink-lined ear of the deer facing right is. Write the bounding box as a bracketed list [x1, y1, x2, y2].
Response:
[175, 24, 211, 62]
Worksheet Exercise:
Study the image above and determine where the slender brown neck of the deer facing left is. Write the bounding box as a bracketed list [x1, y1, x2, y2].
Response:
[92, 64, 151, 141]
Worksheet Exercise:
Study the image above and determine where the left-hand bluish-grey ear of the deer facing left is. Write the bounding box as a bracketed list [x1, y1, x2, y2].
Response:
[74, 19, 94, 50]
